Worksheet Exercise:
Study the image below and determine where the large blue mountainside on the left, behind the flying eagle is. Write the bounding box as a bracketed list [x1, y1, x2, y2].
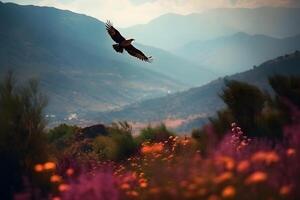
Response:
[0, 2, 213, 123]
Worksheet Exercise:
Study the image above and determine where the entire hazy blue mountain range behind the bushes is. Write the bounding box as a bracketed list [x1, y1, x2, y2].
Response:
[0, 2, 300, 127]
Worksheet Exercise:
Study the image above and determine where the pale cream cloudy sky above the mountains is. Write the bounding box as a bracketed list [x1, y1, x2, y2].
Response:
[0, 0, 300, 27]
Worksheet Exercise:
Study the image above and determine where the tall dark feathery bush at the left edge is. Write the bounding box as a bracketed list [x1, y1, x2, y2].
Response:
[0, 72, 48, 199]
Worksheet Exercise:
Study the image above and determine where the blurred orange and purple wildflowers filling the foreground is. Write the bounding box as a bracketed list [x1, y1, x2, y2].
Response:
[29, 118, 300, 200]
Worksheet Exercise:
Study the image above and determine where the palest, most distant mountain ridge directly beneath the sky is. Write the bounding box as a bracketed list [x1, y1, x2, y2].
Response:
[124, 7, 300, 50]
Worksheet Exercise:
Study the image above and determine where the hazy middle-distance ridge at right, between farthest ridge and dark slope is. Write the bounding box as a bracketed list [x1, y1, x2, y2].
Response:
[177, 32, 300, 75]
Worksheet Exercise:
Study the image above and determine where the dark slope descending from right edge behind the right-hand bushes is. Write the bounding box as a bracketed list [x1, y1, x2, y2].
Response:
[95, 52, 300, 130]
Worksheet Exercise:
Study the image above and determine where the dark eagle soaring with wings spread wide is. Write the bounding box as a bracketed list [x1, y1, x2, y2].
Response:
[105, 21, 152, 62]
